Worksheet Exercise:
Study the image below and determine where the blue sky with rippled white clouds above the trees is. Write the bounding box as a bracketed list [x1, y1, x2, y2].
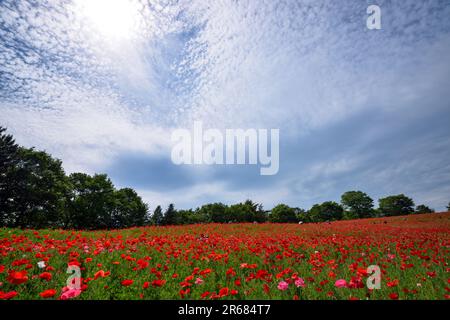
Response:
[0, 0, 450, 210]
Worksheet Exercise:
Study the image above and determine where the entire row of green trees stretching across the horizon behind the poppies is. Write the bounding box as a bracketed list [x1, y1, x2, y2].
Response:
[0, 127, 450, 230]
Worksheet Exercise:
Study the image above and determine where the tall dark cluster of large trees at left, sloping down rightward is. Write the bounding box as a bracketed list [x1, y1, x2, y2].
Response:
[0, 127, 148, 230]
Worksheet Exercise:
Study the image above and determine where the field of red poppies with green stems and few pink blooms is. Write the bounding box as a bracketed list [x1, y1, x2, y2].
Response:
[0, 213, 450, 300]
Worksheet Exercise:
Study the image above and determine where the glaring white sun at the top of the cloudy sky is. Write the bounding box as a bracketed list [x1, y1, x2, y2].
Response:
[75, 0, 140, 40]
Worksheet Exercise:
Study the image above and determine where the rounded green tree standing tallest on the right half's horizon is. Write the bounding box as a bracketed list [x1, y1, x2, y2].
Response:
[341, 191, 373, 219]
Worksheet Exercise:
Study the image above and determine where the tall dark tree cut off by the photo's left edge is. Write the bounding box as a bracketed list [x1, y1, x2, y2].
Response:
[0, 126, 19, 227]
